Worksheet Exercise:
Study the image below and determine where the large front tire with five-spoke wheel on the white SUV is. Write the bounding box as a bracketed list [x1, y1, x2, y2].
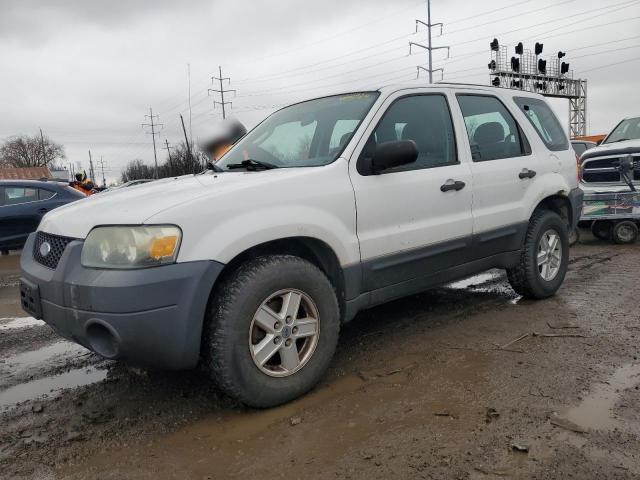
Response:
[203, 255, 340, 408]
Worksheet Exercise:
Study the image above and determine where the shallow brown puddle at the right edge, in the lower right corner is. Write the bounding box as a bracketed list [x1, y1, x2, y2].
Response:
[562, 364, 640, 430]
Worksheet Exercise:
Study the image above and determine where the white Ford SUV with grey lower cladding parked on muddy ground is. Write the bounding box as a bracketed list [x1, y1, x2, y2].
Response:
[21, 84, 582, 407]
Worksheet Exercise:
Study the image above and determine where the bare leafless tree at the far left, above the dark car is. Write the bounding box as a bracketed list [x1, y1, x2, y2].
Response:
[0, 135, 65, 168]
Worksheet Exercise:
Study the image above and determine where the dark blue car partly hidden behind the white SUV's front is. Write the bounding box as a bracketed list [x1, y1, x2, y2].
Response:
[0, 180, 85, 253]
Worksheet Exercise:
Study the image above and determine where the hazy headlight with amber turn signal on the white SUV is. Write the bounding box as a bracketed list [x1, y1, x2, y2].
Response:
[81, 225, 182, 269]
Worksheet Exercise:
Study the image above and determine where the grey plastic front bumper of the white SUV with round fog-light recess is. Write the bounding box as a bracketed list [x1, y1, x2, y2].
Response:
[20, 233, 224, 370]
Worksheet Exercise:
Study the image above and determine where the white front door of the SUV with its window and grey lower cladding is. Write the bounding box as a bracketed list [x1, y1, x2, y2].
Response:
[349, 89, 473, 291]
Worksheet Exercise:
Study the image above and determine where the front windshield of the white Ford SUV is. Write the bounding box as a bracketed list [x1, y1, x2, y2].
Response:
[216, 92, 378, 170]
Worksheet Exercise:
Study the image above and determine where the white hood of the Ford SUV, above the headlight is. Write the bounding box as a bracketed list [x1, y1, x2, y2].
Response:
[38, 169, 298, 238]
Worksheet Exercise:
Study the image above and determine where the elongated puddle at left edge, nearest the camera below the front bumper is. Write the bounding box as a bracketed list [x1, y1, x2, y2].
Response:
[0, 367, 108, 408]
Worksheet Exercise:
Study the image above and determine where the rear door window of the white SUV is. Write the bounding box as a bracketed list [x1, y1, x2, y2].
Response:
[458, 95, 530, 162]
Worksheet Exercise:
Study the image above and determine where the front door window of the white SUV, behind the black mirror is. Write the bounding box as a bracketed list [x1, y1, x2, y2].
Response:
[362, 95, 458, 174]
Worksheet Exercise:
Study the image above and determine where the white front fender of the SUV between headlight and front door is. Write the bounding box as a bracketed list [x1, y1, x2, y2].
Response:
[146, 158, 360, 265]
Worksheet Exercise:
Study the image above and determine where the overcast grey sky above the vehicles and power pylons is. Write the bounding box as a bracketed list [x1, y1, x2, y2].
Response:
[0, 0, 640, 184]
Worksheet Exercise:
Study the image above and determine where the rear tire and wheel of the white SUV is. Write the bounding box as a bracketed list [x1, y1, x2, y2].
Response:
[507, 210, 569, 299]
